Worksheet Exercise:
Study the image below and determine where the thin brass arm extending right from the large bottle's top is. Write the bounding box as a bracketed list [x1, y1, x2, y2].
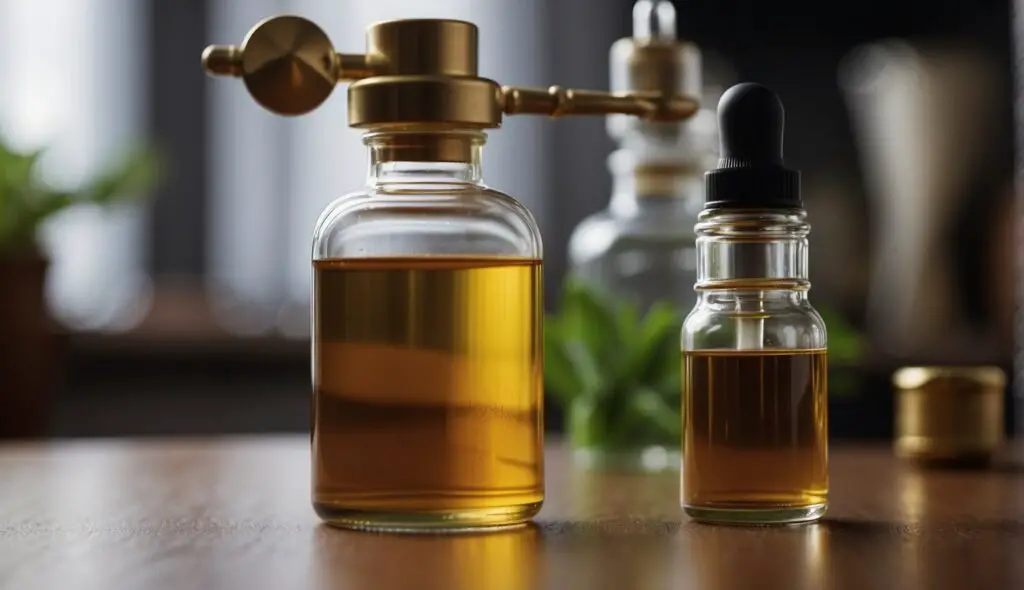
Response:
[502, 86, 699, 121]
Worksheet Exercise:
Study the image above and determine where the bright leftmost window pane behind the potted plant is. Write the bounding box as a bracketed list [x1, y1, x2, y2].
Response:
[0, 0, 148, 329]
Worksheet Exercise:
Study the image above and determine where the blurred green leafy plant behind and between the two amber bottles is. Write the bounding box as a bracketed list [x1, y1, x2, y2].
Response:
[544, 278, 862, 450]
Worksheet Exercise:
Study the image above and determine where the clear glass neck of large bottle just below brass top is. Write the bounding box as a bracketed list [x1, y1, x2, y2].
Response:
[364, 131, 485, 185]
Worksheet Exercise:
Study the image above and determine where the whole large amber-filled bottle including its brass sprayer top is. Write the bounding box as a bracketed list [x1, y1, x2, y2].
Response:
[204, 16, 696, 532]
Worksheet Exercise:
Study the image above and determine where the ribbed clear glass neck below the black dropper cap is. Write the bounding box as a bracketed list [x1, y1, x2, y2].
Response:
[696, 209, 811, 291]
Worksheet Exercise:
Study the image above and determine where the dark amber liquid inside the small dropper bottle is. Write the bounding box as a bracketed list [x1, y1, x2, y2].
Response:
[682, 349, 828, 523]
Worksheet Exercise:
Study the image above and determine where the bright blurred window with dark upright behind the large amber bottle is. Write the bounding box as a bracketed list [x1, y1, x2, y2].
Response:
[0, 0, 549, 338]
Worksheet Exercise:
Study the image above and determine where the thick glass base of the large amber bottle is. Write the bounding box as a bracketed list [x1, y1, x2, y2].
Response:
[313, 502, 541, 534]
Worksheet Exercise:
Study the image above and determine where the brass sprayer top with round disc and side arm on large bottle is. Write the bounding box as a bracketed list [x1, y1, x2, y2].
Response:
[203, 15, 697, 129]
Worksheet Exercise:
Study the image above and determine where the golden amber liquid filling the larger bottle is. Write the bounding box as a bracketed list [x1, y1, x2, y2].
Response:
[312, 256, 544, 530]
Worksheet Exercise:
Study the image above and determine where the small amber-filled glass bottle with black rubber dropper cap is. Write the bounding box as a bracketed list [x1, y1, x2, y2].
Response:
[681, 84, 828, 524]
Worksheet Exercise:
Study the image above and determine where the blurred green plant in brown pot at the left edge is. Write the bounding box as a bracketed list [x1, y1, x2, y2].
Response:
[0, 138, 158, 438]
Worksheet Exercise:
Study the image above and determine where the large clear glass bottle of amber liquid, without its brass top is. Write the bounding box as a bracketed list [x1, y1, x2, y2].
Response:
[312, 129, 544, 526]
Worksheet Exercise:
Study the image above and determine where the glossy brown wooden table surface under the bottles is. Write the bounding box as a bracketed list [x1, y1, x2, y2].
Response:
[0, 437, 1024, 590]
